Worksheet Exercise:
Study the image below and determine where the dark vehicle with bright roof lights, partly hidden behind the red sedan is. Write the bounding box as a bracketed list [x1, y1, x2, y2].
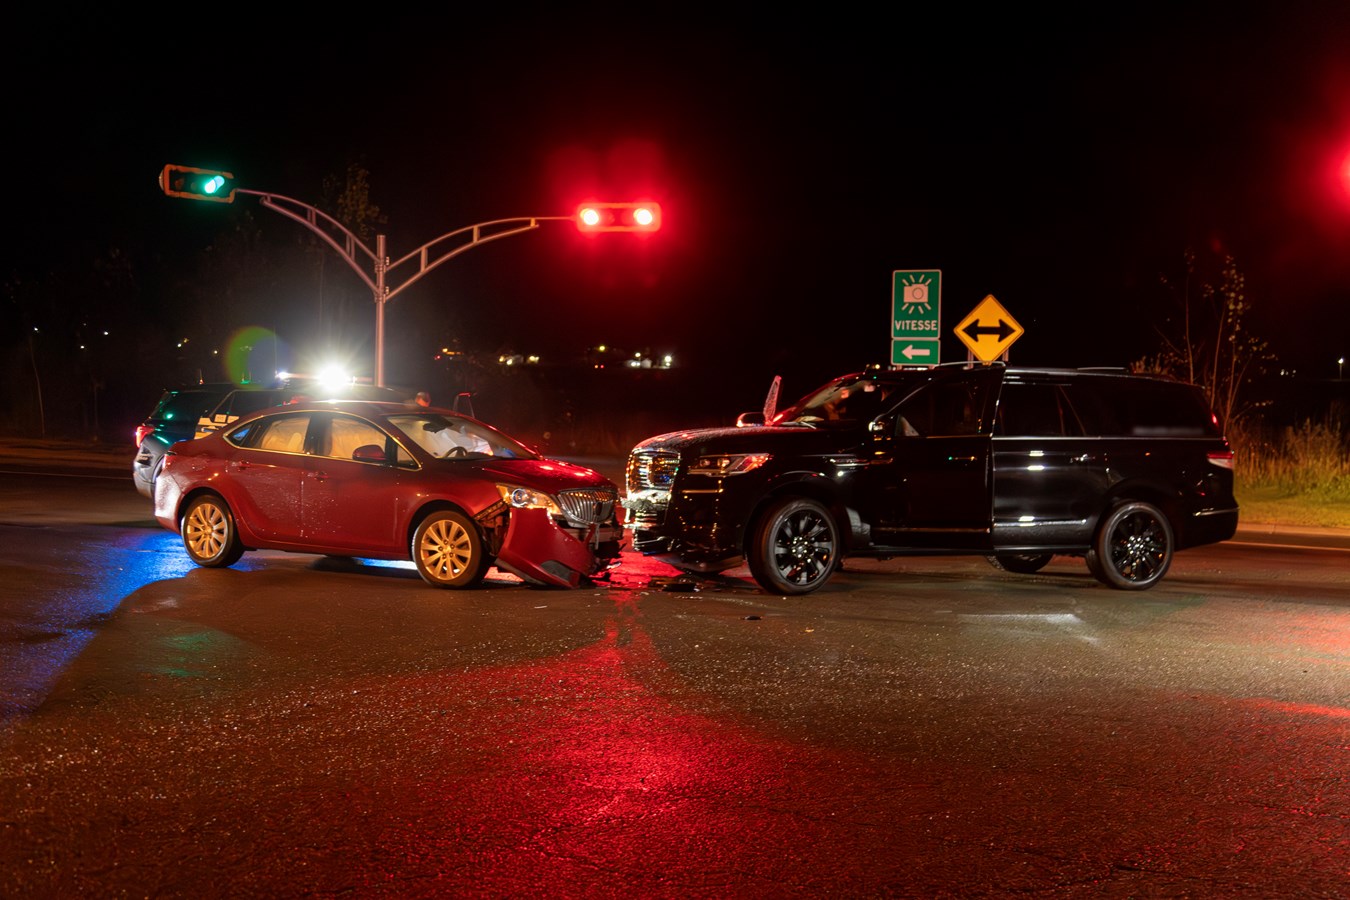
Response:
[131, 378, 412, 499]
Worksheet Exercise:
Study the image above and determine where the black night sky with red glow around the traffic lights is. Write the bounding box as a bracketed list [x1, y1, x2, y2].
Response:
[0, 3, 1350, 393]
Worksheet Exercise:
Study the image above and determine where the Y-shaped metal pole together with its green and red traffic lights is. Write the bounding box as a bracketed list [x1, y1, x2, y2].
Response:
[159, 163, 662, 387]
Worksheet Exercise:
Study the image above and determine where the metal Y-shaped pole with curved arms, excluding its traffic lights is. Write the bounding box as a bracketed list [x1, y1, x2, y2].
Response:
[235, 188, 574, 387]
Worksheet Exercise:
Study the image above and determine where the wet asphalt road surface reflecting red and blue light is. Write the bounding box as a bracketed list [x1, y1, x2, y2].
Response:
[0, 453, 1350, 897]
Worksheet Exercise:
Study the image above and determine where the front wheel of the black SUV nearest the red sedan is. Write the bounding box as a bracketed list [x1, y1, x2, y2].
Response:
[749, 498, 840, 594]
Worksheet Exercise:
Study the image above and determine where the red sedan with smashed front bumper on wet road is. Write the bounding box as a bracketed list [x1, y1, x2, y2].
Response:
[154, 401, 624, 588]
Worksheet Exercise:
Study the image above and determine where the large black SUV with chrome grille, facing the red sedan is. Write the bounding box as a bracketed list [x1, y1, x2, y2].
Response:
[624, 363, 1238, 594]
